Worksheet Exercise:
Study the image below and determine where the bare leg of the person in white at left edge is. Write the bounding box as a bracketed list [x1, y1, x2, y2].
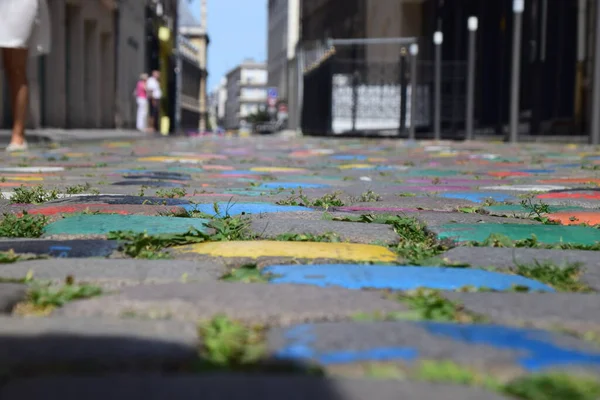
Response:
[2, 49, 29, 145]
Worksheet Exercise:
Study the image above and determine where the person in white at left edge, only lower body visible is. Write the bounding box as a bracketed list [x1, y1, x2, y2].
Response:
[0, 0, 50, 152]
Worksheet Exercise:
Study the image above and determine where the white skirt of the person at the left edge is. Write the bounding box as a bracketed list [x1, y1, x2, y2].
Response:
[0, 0, 50, 57]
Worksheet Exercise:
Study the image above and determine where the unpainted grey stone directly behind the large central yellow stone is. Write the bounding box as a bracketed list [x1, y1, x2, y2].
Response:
[252, 219, 398, 244]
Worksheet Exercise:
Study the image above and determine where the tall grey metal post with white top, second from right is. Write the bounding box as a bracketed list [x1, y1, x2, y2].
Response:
[509, 0, 525, 143]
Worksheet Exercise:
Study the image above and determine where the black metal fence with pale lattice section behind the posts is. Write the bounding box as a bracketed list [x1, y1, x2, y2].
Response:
[302, 54, 467, 138]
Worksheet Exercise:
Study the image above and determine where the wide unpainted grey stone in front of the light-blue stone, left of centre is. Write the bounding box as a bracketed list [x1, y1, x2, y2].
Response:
[56, 282, 406, 325]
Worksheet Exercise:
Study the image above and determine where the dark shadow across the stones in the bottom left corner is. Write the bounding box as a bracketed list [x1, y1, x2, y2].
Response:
[0, 329, 346, 400]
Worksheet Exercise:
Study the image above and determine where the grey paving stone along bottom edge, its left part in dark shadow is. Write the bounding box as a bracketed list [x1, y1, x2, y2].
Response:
[0, 374, 507, 400]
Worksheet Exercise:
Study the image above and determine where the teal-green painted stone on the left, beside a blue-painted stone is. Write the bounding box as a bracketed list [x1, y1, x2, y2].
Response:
[45, 214, 208, 236]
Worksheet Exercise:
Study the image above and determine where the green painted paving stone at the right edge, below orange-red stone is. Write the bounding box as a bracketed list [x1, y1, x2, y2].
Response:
[438, 224, 600, 245]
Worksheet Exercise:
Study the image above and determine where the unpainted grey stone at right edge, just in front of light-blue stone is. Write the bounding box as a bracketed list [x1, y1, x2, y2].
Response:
[443, 292, 600, 333]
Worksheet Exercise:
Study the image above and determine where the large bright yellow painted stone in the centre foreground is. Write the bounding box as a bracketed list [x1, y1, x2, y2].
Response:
[174, 240, 397, 262]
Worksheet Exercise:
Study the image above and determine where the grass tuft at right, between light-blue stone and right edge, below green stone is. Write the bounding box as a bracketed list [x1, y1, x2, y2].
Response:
[511, 260, 593, 293]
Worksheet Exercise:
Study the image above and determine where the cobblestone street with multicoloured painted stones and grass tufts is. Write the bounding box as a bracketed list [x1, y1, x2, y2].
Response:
[0, 137, 600, 400]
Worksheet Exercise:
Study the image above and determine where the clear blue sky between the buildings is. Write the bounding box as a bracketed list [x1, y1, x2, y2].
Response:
[190, 0, 267, 91]
